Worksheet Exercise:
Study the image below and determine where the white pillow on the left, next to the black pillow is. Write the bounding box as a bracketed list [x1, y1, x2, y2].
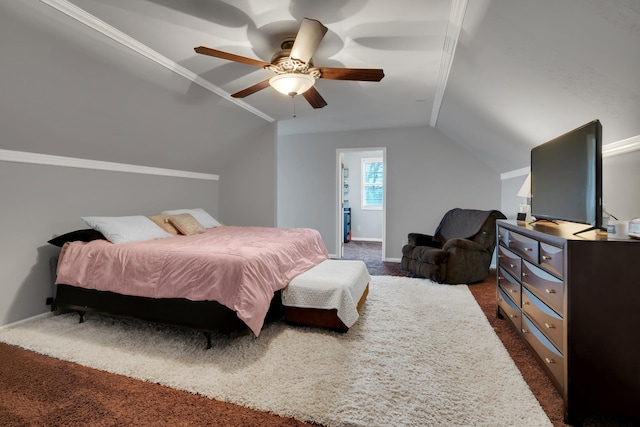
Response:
[80, 215, 173, 243]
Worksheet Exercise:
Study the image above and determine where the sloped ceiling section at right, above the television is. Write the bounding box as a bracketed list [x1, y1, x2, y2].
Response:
[436, 0, 640, 172]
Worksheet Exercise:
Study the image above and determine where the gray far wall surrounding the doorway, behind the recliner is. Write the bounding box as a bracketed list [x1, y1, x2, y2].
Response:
[277, 126, 501, 260]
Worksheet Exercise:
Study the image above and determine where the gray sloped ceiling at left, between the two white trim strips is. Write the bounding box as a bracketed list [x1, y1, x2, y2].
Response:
[0, 1, 274, 174]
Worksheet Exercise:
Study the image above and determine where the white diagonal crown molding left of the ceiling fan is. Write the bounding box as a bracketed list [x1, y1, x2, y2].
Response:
[40, 0, 275, 123]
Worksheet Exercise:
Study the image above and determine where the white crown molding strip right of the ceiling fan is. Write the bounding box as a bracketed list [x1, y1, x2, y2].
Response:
[429, 0, 468, 127]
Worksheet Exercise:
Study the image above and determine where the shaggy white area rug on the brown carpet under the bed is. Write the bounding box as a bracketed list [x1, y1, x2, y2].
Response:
[0, 276, 551, 427]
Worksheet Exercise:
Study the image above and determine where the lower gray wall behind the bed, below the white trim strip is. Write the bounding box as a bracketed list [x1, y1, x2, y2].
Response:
[0, 161, 218, 324]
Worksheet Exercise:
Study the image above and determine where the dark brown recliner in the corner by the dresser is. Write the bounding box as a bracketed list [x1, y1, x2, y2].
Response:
[401, 208, 506, 284]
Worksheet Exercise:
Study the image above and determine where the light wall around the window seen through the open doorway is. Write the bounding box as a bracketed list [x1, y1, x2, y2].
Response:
[344, 151, 383, 241]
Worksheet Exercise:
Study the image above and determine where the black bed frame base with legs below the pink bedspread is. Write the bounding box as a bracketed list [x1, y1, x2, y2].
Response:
[53, 284, 284, 349]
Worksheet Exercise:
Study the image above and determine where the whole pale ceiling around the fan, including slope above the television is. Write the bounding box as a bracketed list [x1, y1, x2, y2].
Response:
[11, 0, 640, 173]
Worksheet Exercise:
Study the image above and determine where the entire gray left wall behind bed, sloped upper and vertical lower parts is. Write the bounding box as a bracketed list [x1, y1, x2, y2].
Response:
[0, 1, 276, 324]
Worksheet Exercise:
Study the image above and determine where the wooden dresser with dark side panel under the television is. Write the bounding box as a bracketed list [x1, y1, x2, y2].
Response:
[496, 220, 640, 425]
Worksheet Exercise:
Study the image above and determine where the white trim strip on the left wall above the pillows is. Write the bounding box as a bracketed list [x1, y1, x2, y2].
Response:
[0, 149, 220, 181]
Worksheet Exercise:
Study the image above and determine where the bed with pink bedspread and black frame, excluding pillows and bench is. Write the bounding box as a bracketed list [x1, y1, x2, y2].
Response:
[55, 226, 328, 347]
